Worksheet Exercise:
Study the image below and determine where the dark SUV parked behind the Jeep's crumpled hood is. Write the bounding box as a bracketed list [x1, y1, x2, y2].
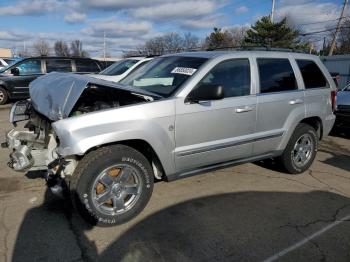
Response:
[0, 57, 101, 105]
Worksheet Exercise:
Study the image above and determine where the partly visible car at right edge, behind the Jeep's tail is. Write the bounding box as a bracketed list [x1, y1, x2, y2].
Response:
[335, 84, 350, 128]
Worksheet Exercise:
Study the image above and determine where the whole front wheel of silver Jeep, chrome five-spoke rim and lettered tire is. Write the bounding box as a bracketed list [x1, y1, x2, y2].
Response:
[71, 145, 153, 226]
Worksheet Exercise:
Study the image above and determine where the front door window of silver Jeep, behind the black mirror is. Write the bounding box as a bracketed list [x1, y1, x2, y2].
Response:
[199, 59, 250, 97]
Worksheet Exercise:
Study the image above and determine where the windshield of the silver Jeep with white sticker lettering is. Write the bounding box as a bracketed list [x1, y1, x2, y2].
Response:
[120, 56, 207, 97]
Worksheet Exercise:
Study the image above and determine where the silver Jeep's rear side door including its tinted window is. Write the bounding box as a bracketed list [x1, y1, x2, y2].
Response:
[253, 57, 305, 155]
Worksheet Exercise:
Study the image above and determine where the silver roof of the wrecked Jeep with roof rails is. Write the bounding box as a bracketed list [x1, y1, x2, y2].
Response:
[166, 50, 317, 59]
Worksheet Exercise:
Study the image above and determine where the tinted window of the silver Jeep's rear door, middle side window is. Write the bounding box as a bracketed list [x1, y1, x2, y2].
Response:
[257, 58, 298, 93]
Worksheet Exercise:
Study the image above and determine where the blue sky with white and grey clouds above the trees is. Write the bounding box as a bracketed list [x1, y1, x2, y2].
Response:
[0, 0, 343, 56]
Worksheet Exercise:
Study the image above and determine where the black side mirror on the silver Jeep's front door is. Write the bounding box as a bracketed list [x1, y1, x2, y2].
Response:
[185, 84, 224, 103]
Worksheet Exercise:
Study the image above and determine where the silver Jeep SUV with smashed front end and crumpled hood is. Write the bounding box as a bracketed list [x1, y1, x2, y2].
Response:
[3, 51, 336, 226]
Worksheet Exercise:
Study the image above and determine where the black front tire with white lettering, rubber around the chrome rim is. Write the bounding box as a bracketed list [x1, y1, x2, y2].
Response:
[70, 145, 154, 226]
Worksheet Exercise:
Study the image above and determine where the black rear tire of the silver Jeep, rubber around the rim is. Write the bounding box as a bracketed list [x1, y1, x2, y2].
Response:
[280, 123, 318, 174]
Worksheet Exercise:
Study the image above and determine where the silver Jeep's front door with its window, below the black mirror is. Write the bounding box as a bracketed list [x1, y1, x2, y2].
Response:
[175, 58, 256, 172]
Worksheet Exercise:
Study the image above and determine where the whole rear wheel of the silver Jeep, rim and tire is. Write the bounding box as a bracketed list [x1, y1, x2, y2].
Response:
[281, 123, 318, 174]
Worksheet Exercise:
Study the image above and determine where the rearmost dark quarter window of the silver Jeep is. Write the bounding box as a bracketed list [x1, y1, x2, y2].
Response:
[297, 60, 329, 89]
